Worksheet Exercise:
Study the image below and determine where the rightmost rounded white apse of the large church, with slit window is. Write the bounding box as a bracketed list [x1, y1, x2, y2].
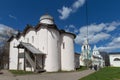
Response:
[61, 33, 75, 71]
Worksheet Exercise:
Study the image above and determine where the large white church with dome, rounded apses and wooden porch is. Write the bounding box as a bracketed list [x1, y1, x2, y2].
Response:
[8, 14, 76, 72]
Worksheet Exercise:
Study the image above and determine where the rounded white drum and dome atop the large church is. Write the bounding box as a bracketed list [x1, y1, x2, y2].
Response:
[40, 14, 54, 24]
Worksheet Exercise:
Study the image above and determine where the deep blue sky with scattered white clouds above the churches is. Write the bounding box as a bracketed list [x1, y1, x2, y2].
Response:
[0, 0, 120, 52]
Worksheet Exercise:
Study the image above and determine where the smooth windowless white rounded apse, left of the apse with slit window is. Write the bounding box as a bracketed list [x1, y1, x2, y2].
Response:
[45, 29, 60, 72]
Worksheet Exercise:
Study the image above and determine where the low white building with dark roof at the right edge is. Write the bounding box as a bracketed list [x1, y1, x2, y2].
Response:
[109, 53, 120, 67]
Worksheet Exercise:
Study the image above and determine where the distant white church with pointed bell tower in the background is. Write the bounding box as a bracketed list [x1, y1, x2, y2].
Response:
[80, 39, 104, 67]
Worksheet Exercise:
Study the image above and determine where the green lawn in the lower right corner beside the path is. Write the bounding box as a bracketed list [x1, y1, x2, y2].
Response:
[80, 67, 120, 80]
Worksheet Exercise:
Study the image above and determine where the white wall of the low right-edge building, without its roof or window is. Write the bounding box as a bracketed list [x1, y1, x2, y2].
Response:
[109, 54, 120, 67]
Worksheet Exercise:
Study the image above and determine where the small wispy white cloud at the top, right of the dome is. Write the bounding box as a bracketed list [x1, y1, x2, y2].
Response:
[58, 0, 85, 20]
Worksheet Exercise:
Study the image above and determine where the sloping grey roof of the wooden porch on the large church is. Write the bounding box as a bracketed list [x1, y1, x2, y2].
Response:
[17, 42, 44, 54]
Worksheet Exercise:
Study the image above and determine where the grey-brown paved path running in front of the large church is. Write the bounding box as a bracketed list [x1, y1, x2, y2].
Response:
[0, 70, 94, 80]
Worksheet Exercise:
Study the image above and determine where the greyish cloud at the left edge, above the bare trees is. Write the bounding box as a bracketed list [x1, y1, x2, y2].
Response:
[0, 24, 17, 42]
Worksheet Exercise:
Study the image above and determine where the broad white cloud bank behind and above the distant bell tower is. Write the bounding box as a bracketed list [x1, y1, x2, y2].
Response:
[75, 21, 120, 44]
